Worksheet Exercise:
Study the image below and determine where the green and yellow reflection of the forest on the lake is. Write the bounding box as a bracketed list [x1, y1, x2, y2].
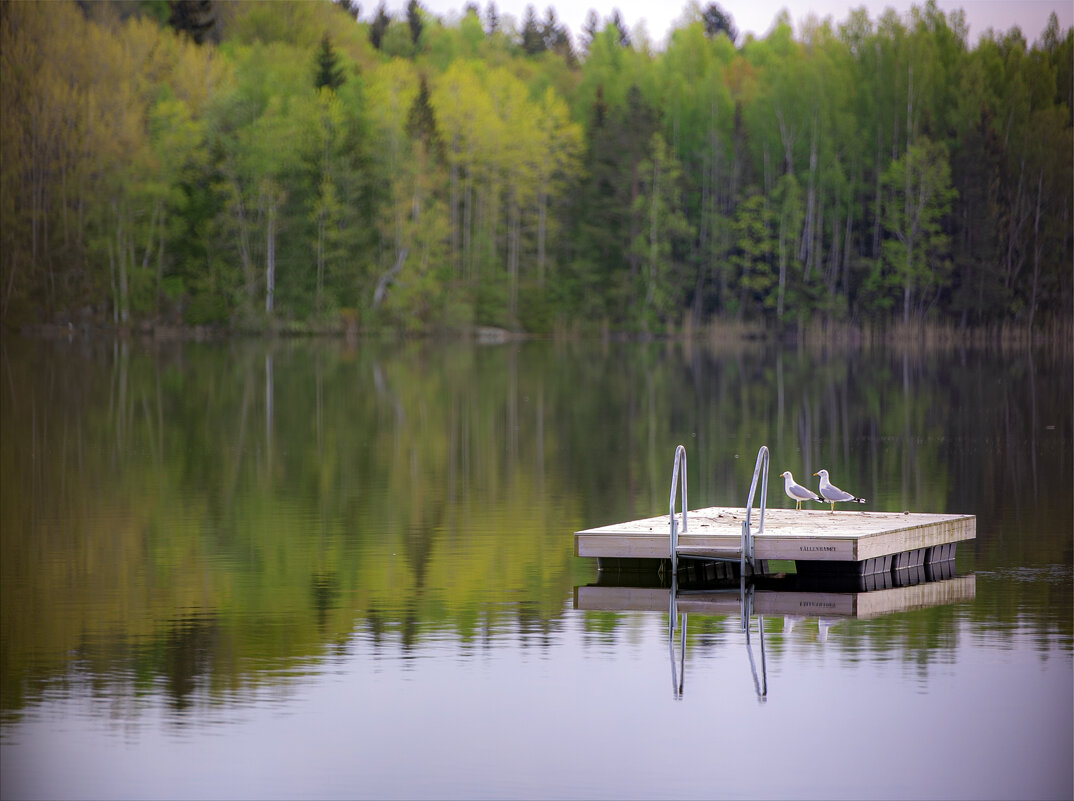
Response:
[0, 341, 1074, 708]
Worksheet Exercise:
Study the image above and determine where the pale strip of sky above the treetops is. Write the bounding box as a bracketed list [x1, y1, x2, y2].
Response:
[395, 0, 1074, 48]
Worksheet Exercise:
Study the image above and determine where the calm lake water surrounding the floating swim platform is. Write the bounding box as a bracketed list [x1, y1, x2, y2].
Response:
[0, 335, 1074, 799]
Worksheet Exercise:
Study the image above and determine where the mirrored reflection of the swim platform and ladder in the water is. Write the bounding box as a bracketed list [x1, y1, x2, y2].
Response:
[575, 562, 976, 701]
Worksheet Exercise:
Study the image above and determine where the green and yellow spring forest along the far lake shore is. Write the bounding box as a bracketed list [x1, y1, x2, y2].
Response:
[0, 0, 1074, 335]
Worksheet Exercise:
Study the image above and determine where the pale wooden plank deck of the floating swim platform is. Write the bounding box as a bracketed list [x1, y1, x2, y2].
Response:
[575, 507, 977, 573]
